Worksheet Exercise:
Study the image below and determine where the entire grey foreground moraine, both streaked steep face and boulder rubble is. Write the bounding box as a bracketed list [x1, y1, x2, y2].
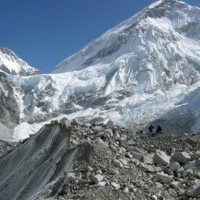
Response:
[0, 119, 200, 200]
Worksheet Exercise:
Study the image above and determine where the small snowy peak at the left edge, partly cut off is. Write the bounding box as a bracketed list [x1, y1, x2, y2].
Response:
[0, 46, 41, 76]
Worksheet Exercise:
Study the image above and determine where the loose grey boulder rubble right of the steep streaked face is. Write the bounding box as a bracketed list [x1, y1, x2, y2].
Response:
[40, 120, 200, 200]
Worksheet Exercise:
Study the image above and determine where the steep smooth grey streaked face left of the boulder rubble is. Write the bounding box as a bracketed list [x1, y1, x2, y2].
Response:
[0, 122, 92, 200]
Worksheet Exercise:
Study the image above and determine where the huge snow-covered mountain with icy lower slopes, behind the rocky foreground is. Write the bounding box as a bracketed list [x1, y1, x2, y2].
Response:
[3, 0, 200, 139]
